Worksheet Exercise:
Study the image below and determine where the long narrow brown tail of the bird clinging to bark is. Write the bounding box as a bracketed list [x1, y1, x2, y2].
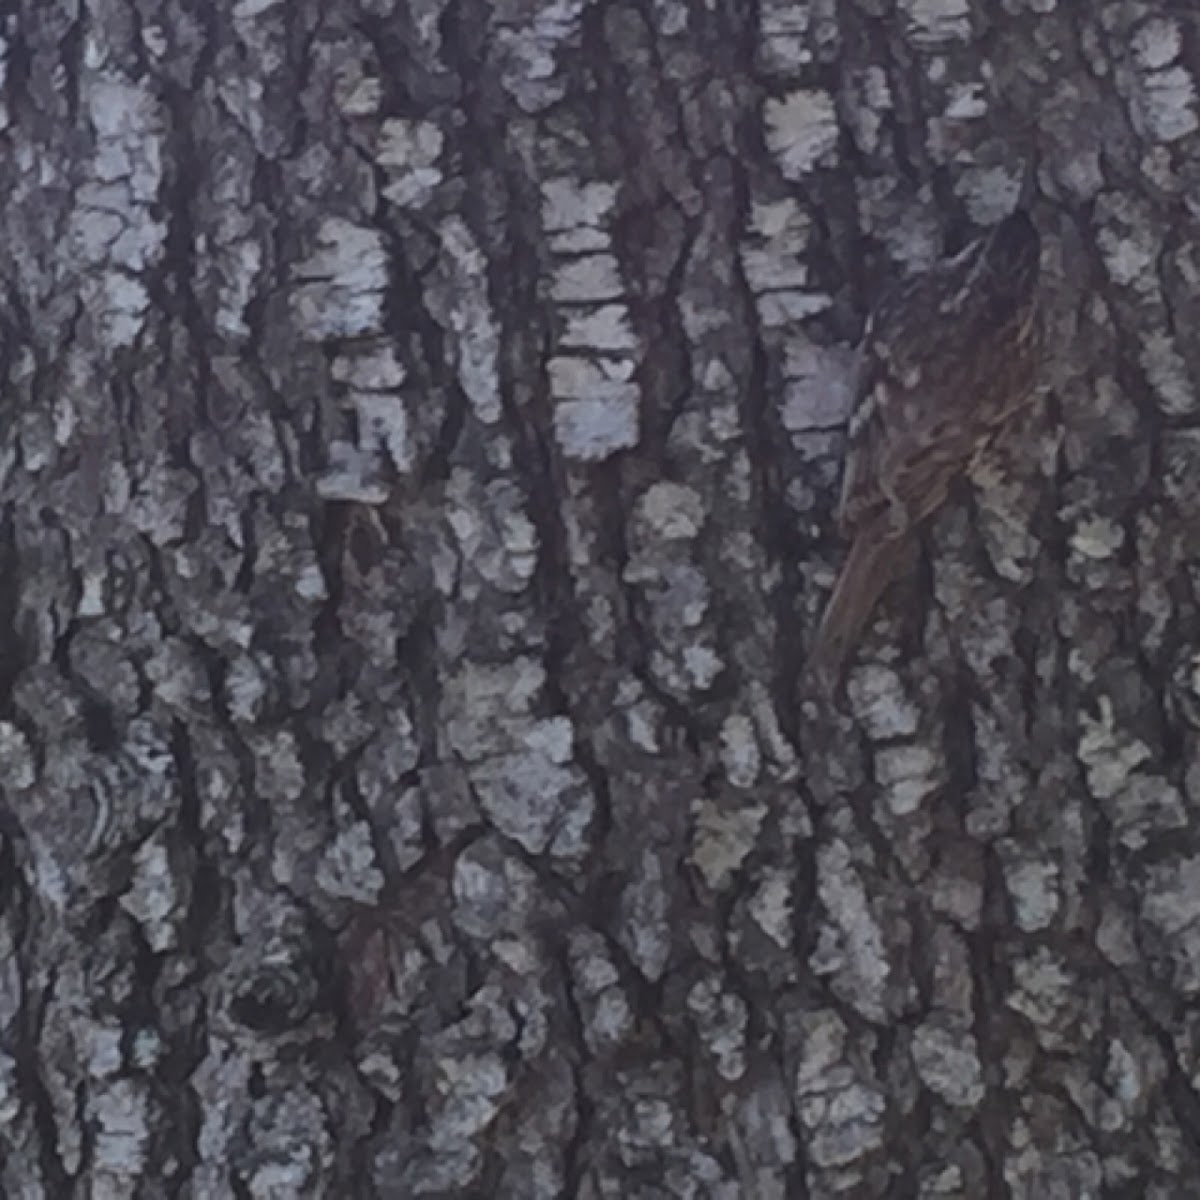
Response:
[806, 528, 908, 692]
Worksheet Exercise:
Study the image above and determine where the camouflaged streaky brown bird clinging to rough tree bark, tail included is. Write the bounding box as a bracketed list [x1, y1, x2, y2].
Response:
[809, 211, 1042, 685]
